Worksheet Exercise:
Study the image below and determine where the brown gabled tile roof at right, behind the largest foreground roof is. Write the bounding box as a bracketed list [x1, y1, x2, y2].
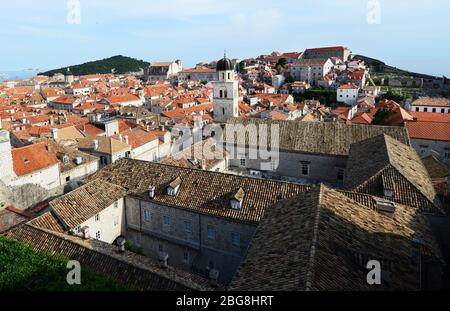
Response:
[344, 135, 440, 213]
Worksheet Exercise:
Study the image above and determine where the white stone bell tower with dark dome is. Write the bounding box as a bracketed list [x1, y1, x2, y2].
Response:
[212, 53, 239, 123]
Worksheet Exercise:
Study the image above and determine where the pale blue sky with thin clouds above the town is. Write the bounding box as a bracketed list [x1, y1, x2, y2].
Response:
[0, 0, 450, 76]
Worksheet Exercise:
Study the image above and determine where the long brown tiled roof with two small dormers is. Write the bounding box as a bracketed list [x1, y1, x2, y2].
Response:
[89, 159, 309, 223]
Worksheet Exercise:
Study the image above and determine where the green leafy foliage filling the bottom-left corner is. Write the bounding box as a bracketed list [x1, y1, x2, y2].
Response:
[0, 236, 127, 291]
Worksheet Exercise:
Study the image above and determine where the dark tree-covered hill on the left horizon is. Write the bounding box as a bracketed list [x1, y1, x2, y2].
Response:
[39, 55, 150, 76]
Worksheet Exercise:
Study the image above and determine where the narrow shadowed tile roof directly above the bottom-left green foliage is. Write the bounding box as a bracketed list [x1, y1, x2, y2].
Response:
[5, 224, 215, 291]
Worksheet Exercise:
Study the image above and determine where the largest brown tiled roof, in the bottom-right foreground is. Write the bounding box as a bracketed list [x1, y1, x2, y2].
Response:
[231, 185, 443, 291]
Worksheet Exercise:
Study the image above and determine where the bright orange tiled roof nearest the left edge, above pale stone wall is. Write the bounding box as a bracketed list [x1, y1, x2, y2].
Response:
[12, 143, 59, 176]
